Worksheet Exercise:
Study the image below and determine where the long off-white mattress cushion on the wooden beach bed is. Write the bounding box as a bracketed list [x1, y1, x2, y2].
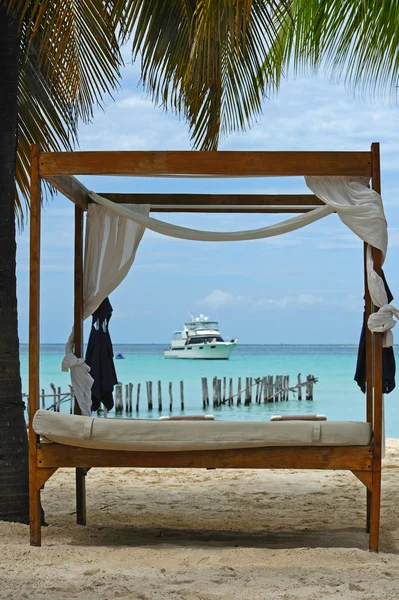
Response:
[33, 410, 372, 452]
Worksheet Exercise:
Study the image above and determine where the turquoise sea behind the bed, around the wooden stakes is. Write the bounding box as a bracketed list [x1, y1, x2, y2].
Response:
[21, 343, 399, 438]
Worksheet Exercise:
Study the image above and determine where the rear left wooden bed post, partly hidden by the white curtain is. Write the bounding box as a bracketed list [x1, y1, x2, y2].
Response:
[74, 206, 87, 525]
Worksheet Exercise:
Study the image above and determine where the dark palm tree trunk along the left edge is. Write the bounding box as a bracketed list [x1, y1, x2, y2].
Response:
[0, 0, 29, 523]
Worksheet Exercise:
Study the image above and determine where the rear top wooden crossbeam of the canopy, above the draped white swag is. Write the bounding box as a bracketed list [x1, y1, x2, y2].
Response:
[100, 192, 324, 213]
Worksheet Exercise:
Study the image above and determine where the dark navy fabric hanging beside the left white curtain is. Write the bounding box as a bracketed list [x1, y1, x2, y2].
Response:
[86, 298, 118, 411]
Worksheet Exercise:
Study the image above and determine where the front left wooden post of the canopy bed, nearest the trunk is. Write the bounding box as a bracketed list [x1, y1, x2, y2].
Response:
[28, 144, 41, 546]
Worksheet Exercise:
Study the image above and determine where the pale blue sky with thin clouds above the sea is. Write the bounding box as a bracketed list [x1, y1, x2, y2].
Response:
[17, 56, 399, 344]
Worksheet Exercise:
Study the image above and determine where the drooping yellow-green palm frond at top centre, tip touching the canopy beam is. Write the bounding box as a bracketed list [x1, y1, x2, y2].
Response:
[119, 0, 289, 150]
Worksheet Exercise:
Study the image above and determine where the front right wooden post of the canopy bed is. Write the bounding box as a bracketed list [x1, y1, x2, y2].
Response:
[369, 143, 383, 552]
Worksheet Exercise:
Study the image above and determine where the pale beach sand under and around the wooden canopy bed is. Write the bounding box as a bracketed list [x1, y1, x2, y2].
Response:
[0, 440, 399, 600]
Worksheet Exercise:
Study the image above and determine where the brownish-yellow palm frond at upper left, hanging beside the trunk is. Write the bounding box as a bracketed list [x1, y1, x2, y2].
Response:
[8, 0, 125, 222]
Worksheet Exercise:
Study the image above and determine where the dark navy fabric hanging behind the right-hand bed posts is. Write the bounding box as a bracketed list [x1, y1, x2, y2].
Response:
[355, 272, 396, 394]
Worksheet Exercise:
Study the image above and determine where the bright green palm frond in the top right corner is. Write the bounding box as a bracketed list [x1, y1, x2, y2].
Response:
[279, 0, 399, 100]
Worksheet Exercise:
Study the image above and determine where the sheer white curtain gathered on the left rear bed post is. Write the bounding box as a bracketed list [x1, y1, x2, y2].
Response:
[62, 204, 150, 416]
